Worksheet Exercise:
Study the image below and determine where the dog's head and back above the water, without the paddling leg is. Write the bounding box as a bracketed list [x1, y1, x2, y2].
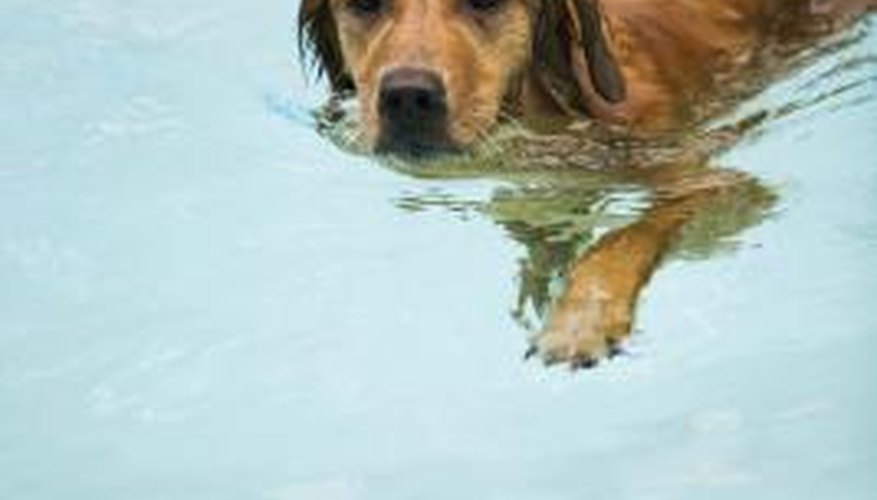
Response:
[299, 0, 877, 153]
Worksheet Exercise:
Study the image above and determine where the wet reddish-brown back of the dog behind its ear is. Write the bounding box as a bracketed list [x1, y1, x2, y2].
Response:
[592, 0, 877, 130]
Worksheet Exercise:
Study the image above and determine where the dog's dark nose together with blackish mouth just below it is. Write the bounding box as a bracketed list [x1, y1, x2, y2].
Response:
[378, 68, 448, 152]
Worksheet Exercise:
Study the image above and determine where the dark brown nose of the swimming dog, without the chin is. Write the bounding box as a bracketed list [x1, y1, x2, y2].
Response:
[378, 68, 447, 130]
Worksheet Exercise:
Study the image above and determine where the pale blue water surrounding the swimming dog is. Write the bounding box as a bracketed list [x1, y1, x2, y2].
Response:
[0, 0, 877, 500]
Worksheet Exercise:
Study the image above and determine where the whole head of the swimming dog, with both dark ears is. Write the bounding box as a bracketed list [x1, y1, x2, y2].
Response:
[299, 0, 624, 154]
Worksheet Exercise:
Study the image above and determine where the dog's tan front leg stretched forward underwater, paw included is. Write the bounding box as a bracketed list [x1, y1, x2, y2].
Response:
[530, 170, 746, 368]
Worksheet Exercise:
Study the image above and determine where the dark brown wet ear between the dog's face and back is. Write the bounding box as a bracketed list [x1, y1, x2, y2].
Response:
[533, 0, 626, 112]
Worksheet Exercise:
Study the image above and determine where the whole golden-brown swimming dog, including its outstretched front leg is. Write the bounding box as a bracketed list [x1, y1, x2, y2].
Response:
[298, 0, 877, 367]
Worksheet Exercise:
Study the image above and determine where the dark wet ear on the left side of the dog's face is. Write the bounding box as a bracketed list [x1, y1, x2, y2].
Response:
[298, 0, 353, 92]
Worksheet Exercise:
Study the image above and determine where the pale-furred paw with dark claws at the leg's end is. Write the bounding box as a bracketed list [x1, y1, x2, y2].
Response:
[526, 284, 633, 369]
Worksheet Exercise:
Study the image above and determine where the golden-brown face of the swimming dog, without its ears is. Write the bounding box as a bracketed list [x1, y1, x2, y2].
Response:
[330, 0, 531, 153]
